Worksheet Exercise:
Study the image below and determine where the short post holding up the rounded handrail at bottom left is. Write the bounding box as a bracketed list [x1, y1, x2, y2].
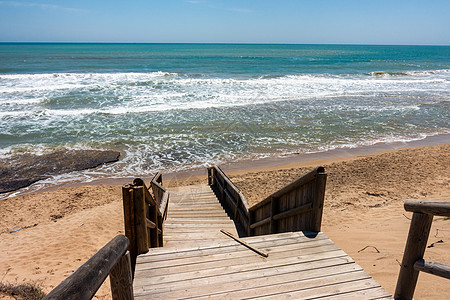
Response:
[109, 251, 134, 300]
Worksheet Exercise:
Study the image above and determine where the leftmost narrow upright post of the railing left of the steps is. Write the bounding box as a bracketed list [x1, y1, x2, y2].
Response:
[122, 184, 137, 277]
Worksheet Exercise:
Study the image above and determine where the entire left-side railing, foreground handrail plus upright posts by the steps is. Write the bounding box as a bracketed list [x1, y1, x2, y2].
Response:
[45, 173, 169, 300]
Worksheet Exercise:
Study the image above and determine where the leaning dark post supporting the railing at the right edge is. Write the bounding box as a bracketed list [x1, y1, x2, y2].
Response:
[394, 212, 433, 299]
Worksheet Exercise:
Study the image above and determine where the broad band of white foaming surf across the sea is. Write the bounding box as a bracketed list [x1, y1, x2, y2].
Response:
[0, 70, 450, 117]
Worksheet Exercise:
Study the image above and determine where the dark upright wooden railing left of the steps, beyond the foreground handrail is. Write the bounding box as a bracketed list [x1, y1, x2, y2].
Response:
[122, 173, 169, 274]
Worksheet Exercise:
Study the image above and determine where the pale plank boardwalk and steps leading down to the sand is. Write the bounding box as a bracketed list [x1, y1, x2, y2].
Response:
[133, 185, 392, 299]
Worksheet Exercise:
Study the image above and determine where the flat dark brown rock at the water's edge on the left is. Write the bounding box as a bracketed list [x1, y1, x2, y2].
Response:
[0, 150, 120, 193]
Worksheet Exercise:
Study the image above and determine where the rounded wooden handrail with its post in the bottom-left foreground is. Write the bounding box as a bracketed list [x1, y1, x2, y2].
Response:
[44, 235, 133, 300]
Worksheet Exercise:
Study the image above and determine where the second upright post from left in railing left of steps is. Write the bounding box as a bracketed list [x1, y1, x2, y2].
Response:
[133, 186, 149, 255]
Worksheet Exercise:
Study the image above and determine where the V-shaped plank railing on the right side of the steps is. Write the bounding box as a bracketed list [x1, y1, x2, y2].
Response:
[208, 166, 327, 236]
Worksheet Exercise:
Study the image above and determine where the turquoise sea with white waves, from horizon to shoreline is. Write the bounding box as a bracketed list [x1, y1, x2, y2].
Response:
[0, 44, 450, 185]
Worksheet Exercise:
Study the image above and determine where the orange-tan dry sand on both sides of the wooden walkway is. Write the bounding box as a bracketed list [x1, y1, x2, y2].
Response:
[0, 144, 450, 299]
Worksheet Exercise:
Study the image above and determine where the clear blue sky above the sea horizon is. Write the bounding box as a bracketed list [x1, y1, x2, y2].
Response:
[0, 0, 450, 45]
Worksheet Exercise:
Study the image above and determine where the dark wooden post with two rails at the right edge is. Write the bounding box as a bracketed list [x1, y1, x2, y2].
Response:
[395, 199, 450, 299]
